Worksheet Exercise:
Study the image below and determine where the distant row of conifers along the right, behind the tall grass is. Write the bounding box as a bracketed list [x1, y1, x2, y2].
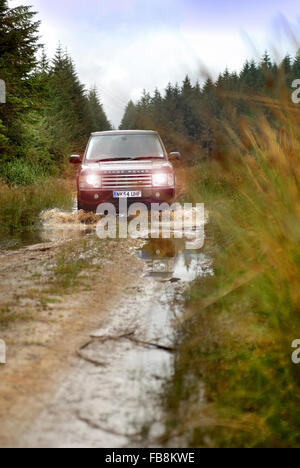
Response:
[120, 51, 300, 161]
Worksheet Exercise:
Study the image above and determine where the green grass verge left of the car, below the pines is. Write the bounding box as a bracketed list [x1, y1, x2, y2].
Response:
[0, 178, 72, 236]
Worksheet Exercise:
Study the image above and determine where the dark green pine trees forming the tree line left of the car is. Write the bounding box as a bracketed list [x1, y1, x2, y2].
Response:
[0, 0, 111, 183]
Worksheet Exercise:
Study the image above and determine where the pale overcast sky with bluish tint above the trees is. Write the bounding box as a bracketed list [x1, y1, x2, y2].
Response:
[9, 0, 300, 127]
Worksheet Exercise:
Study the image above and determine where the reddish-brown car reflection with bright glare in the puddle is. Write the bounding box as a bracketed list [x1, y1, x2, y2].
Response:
[138, 239, 213, 281]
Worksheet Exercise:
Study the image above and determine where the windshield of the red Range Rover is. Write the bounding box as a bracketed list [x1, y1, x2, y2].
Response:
[86, 134, 164, 161]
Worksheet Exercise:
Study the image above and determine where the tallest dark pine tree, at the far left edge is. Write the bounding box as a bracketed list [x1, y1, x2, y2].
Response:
[0, 0, 39, 162]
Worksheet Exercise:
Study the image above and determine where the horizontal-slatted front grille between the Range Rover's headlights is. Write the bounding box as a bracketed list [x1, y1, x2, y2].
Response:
[102, 174, 152, 189]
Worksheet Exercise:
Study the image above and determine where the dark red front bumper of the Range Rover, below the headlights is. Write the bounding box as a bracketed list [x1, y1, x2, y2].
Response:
[78, 187, 175, 211]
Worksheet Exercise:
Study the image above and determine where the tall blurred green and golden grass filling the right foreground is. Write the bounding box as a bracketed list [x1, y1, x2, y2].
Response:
[167, 94, 300, 447]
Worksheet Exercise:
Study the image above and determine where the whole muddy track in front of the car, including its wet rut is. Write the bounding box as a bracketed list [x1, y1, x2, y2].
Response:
[0, 203, 212, 447]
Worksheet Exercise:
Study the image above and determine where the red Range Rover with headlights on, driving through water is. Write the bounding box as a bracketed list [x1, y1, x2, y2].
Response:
[70, 130, 180, 211]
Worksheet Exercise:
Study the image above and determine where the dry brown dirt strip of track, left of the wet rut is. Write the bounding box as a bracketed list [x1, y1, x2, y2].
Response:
[0, 236, 143, 447]
